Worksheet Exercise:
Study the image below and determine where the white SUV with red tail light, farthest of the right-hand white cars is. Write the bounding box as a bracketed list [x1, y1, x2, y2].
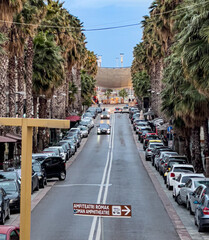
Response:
[166, 164, 195, 190]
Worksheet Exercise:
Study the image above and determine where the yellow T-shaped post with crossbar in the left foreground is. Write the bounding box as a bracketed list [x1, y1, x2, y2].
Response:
[0, 118, 70, 240]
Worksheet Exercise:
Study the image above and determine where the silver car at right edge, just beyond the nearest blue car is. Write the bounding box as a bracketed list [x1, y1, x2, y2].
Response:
[188, 183, 209, 214]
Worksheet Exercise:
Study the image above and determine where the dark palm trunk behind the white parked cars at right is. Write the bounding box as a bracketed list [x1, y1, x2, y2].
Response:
[192, 127, 203, 173]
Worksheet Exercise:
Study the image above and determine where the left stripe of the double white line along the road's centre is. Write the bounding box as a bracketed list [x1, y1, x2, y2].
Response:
[88, 115, 115, 240]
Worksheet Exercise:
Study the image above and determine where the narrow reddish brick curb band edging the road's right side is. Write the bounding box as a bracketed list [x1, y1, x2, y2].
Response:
[132, 130, 192, 240]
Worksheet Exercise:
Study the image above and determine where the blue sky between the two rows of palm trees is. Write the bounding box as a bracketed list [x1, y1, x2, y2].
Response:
[64, 0, 153, 67]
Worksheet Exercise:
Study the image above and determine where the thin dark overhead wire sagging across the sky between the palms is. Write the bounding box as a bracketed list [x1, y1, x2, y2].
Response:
[0, 1, 209, 32]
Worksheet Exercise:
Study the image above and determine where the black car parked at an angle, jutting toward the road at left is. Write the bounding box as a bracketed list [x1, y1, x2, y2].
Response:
[42, 157, 66, 181]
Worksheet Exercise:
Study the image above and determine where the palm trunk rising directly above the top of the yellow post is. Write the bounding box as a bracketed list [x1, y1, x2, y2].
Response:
[26, 37, 34, 118]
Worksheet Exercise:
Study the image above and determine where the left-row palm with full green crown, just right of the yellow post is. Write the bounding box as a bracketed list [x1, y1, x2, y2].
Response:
[33, 32, 64, 149]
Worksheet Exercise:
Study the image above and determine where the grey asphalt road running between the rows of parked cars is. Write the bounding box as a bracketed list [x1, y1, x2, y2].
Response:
[31, 114, 179, 240]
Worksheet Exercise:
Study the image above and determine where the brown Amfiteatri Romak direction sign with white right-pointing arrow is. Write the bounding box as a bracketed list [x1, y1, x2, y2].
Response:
[73, 203, 131, 218]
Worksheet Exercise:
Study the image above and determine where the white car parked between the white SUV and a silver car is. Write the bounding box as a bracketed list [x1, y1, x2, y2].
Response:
[173, 173, 204, 200]
